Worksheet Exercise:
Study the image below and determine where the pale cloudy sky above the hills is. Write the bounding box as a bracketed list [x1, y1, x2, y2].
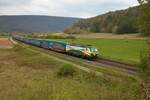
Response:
[0, 0, 138, 18]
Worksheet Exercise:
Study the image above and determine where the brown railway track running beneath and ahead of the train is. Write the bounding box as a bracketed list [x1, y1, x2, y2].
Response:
[13, 38, 138, 75]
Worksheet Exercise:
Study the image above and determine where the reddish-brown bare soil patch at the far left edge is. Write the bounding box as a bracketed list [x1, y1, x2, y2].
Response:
[0, 38, 13, 49]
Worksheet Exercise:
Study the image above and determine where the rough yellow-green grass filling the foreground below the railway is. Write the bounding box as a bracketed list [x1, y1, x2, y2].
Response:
[0, 46, 142, 100]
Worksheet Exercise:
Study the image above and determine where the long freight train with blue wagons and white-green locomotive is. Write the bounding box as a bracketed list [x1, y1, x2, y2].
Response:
[13, 36, 98, 59]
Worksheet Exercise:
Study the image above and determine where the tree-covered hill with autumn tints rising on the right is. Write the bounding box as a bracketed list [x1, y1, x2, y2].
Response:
[69, 7, 139, 34]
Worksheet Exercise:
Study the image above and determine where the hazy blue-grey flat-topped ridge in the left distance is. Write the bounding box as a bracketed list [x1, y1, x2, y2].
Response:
[0, 15, 79, 32]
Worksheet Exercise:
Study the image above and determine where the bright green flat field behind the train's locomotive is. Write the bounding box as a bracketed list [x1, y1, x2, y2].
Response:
[50, 38, 147, 63]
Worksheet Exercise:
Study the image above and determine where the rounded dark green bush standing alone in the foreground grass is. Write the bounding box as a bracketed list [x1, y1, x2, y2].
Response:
[57, 65, 76, 77]
